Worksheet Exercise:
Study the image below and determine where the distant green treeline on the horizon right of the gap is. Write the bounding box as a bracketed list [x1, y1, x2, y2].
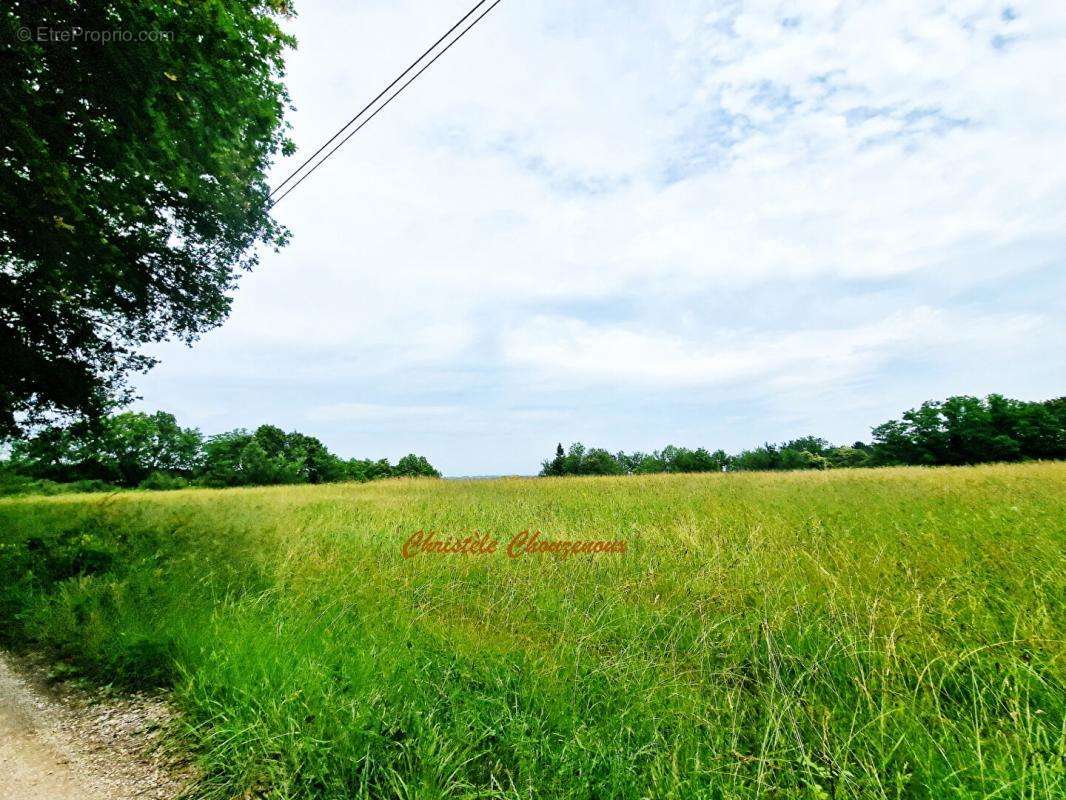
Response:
[540, 395, 1066, 476]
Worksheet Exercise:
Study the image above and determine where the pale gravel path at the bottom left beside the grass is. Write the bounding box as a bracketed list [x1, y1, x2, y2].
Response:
[0, 653, 191, 800]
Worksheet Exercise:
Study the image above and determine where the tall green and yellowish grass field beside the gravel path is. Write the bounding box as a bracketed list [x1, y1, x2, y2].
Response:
[0, 463, 1066, 800]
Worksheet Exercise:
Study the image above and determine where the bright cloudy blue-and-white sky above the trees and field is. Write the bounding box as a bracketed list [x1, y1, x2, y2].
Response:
[135, 0, 1066, 476]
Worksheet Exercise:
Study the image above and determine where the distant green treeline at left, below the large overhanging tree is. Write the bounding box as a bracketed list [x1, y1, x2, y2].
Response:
[0, 412, 440, 493]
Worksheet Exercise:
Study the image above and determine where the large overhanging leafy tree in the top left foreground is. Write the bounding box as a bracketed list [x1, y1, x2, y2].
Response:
[0, 0, 293, 436]
